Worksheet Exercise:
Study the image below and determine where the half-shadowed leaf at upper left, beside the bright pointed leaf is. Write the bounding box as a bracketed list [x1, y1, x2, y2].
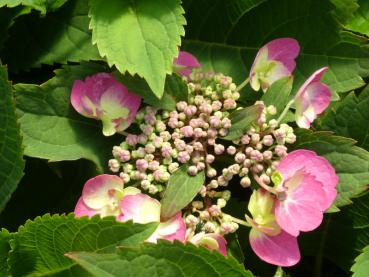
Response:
[0, 0, 101, 71]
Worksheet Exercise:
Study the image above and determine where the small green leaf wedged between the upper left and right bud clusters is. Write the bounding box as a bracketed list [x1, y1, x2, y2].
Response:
[222, 104, 263, 140]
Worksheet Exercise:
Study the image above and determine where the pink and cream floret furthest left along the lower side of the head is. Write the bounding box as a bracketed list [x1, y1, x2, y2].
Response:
[74, 174, 141, 217]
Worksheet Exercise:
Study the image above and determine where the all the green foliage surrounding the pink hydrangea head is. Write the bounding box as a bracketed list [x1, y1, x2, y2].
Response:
[0, 0, 369, 276]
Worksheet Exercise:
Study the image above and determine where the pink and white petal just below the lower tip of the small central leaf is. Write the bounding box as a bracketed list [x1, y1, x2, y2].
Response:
[147, 212, 186, 243]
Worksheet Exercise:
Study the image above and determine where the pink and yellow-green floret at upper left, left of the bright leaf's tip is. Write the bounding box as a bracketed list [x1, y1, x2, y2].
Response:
[71, 73, 141, 136]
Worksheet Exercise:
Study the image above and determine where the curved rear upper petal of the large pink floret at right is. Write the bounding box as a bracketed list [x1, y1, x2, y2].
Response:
[276, 149, 339, 208]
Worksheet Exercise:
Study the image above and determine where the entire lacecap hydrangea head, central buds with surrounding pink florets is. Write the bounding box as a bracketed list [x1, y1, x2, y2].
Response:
[71, 38, 338, 266]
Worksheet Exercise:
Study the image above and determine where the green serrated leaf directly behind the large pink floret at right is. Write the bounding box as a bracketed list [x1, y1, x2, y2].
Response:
[291, 129, 369, 207]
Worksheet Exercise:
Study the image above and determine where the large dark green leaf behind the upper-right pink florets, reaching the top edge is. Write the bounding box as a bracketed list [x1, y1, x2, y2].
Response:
[184, 0, 369, 93]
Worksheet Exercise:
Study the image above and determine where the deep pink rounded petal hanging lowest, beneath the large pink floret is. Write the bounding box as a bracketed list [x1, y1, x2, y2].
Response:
[249, 228, 300, 266]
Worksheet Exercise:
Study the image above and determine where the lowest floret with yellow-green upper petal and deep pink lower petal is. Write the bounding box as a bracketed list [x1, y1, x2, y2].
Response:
[246, 189, 300, 266]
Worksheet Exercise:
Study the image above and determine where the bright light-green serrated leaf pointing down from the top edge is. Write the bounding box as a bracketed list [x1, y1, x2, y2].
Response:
[90, 0, 186, 98]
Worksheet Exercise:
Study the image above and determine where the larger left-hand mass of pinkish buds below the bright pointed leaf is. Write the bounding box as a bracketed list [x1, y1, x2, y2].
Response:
[109, 73, 239, 194]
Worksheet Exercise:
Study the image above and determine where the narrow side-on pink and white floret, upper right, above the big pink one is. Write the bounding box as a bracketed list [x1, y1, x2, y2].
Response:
[295, 67, 332, 128]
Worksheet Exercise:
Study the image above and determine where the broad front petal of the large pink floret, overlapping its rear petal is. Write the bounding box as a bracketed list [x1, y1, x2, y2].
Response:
[275, 173, 326, 237]
